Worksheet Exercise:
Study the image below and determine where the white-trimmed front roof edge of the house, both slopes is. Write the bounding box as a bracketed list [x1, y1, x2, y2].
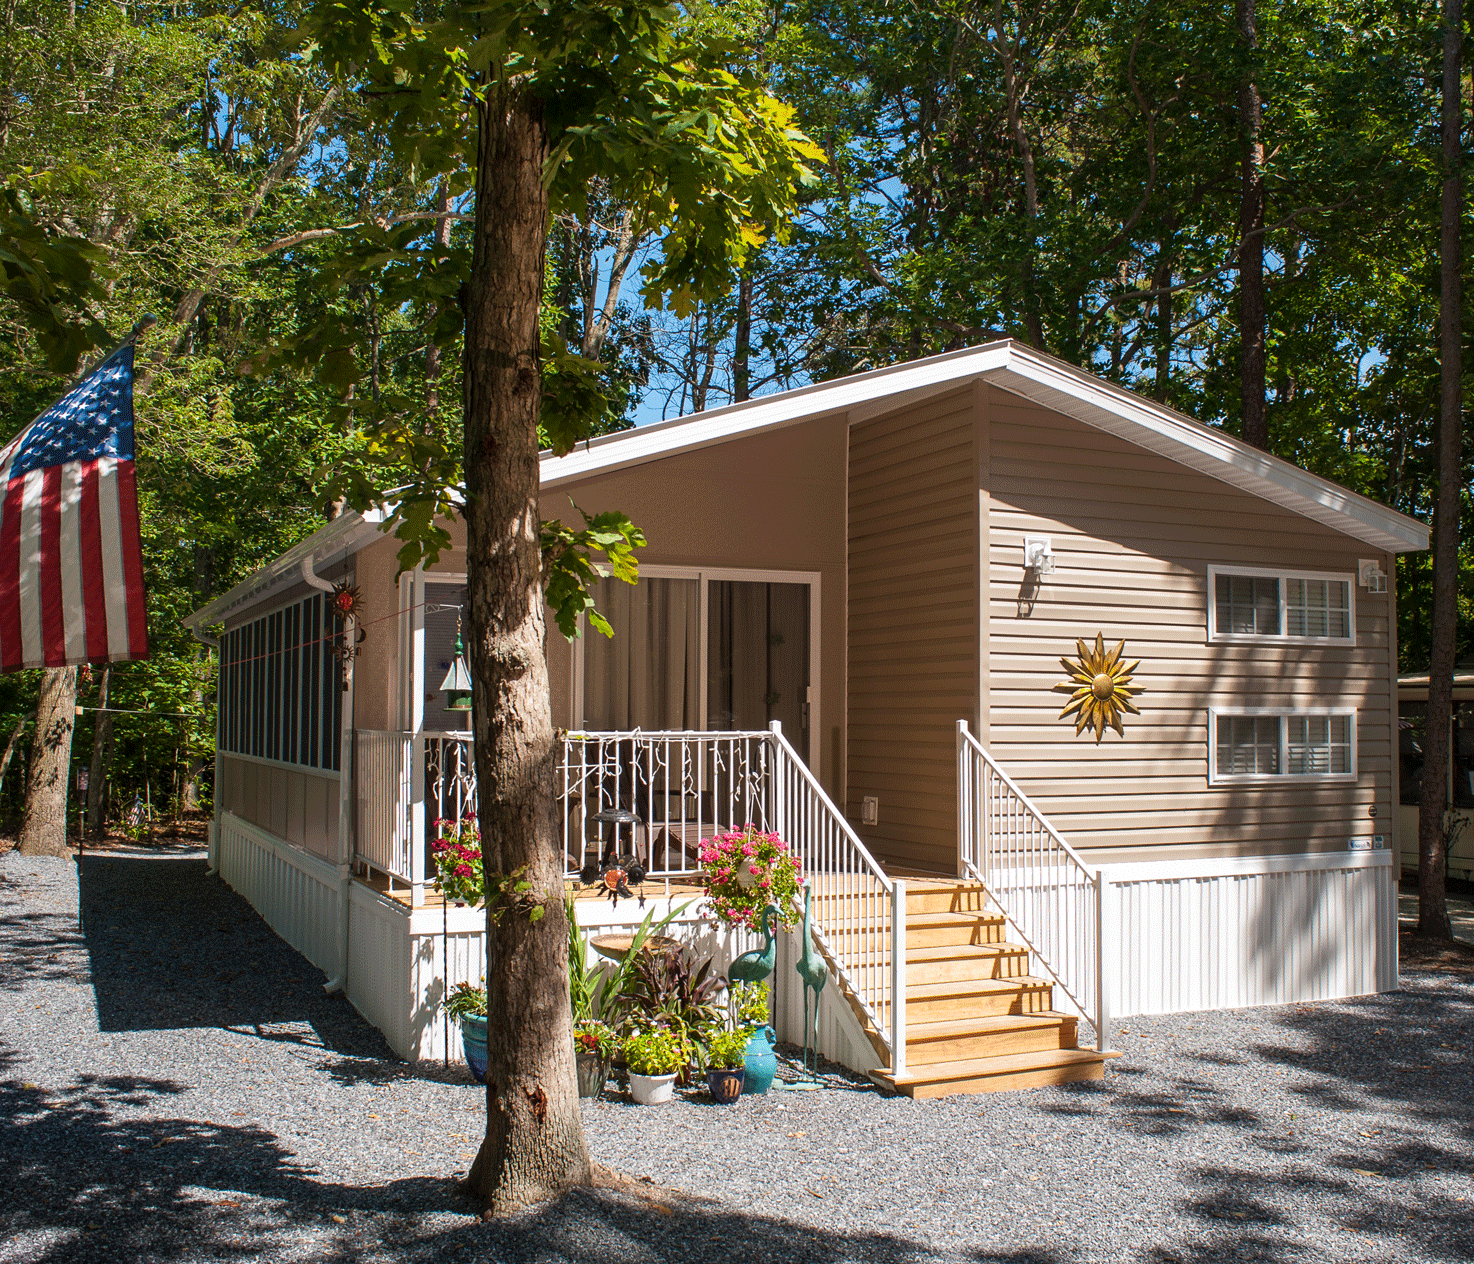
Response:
[542, 339, 1428, 552]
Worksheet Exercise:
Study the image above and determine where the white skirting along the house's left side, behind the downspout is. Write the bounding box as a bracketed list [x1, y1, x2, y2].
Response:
[215, 812, 339, 977]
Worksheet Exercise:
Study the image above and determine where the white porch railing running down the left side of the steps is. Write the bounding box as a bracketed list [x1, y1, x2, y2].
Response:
[357, 723, 907, 1075]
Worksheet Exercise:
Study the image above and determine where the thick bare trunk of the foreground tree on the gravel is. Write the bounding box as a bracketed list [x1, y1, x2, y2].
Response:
[463, 90, 590, 1214]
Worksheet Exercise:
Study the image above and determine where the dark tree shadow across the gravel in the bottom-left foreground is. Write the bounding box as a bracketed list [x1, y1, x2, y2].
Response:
[0, 1050, 949, 1264]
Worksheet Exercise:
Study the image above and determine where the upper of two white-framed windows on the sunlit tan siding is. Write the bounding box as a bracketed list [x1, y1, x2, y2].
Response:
[1207, 566, 1356, 645]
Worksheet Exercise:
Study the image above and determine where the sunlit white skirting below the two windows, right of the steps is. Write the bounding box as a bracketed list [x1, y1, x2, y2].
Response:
[1104, 852, 1397, 1017]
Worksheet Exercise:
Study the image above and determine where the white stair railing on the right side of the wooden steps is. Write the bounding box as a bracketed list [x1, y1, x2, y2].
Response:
[957, 720, 1110, 1052]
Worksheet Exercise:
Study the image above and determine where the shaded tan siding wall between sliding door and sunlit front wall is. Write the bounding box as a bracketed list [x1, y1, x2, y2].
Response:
[845, 387, 979, 872]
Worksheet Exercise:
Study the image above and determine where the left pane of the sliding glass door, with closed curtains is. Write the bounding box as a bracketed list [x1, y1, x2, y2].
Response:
[584, 579, 702, 732]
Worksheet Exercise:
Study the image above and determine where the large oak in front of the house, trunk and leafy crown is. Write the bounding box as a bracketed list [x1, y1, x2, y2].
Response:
[312, 0, 817, 1212]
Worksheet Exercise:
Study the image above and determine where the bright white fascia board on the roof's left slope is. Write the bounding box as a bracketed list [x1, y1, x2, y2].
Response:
[542, 342, 1010, 491]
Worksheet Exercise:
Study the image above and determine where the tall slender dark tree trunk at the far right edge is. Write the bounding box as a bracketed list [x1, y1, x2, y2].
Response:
[1418, 0, 1464, 940]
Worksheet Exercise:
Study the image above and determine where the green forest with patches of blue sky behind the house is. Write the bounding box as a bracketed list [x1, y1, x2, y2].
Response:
[0, 0, 1474, 836]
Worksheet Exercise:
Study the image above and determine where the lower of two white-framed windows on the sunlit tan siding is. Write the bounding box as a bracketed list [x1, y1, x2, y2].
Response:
[1209, 707, 1356, 785]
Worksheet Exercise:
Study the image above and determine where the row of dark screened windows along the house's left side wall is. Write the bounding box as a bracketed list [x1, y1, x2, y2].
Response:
[218, 594, 343, 772]
